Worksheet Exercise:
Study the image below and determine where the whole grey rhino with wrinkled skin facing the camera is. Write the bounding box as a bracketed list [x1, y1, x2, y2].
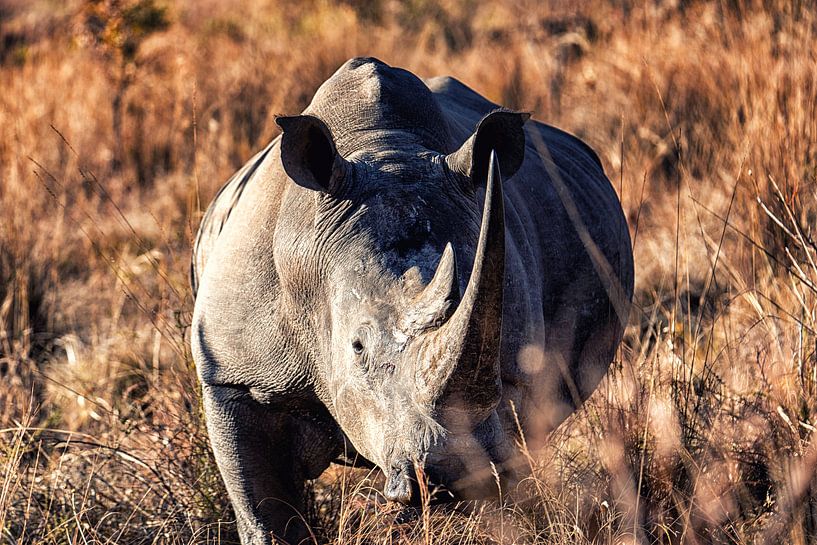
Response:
[192, 59, 633, 544]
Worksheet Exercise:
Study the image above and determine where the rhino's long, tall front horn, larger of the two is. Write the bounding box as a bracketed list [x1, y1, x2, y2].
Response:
[425, 151, 505, 408]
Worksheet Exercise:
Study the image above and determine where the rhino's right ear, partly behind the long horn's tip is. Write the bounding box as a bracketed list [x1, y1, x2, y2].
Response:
[445, 110, 530, 187]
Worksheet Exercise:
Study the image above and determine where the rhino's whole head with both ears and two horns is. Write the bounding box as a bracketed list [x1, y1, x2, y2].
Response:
[274, 101, 528, 503]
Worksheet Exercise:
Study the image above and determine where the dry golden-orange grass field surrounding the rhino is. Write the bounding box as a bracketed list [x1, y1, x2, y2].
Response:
[0, 0, 817, 545]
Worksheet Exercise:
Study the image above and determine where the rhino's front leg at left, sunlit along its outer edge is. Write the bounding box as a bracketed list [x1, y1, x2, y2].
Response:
[203, 386, 335, 545]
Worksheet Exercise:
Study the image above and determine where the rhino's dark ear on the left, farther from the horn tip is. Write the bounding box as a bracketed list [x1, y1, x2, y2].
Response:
[275, 115, 345, 193]
